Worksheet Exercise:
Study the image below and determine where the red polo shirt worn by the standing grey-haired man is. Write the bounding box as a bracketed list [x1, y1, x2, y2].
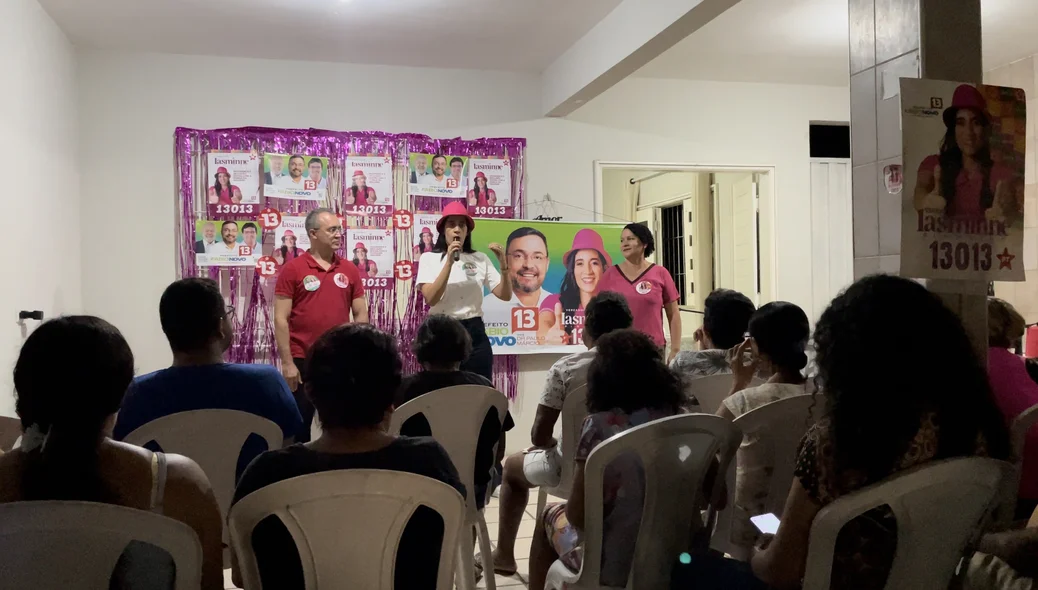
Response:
[274, 251, 364, 358]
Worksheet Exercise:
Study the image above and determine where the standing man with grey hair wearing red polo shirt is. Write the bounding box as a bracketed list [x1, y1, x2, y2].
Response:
[274, 208, 367, 443]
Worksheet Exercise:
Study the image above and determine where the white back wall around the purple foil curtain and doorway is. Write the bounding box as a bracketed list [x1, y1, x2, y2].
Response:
[79, 52, 847, 449]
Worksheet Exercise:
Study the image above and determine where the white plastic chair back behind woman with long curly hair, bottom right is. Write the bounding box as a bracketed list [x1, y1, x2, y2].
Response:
[803, 457, 1011, 590]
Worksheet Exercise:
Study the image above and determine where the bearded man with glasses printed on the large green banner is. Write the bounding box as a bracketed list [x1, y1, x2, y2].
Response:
[484, 227, 551, 323]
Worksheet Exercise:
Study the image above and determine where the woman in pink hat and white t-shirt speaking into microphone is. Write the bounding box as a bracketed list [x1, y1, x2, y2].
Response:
[416, 202, 512, 379]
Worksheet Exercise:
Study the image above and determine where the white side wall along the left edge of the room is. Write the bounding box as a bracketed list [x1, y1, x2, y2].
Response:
[0, 0, 81, 415]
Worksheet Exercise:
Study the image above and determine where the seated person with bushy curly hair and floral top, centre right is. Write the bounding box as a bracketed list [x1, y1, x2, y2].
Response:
[529, 329, 683, 590]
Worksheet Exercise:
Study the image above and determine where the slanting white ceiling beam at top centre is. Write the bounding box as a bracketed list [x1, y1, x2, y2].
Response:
[541, 0, 739, 116]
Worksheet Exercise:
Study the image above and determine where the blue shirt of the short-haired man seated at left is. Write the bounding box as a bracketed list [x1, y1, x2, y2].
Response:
[113, 364, 303, 475]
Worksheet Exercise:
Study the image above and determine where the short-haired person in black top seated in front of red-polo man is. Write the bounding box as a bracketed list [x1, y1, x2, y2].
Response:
[234, 324, 465, 590]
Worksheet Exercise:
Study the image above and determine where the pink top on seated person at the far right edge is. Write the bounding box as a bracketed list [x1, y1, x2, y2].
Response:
[987, 348, 1038, 500]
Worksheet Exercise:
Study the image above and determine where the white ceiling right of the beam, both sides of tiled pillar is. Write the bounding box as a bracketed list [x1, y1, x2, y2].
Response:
[635, 0, 1038, 86]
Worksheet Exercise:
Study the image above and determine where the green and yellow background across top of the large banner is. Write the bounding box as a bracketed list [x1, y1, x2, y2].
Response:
[472, 219, 624, 290]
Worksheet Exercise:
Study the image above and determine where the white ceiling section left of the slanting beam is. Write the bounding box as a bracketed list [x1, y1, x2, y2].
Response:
[39, 0, 621, 73]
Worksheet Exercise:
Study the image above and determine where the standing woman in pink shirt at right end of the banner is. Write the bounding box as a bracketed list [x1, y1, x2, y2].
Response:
[598, 223, 681, 364]
